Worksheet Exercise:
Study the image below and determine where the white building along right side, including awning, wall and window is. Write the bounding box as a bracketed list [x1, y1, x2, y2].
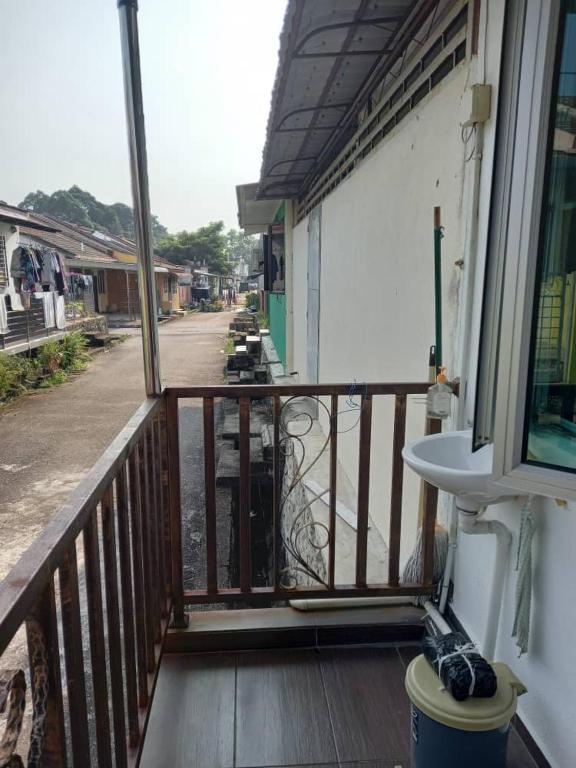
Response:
[237, 0, 576, 768]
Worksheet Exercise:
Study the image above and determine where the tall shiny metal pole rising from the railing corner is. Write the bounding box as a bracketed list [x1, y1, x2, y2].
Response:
[118, 0, 162, 396]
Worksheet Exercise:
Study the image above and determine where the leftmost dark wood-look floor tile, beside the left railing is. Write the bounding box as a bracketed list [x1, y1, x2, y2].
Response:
[140, 654, 236, 768]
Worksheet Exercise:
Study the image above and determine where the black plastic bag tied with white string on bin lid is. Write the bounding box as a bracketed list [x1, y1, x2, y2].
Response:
[422, 632, 498, 701]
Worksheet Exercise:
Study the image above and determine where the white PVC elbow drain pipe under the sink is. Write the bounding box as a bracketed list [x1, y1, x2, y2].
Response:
[460, 511, 512, 661]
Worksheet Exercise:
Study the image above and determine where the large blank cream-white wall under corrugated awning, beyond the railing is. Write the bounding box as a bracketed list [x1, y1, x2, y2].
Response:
[294, 64, 468, 559]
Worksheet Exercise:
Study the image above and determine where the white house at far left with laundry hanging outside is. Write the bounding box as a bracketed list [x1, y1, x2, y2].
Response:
[0, 203, 66, 353]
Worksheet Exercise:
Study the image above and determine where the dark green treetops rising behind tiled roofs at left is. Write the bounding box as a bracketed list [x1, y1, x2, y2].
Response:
[20, 185, 168, 240]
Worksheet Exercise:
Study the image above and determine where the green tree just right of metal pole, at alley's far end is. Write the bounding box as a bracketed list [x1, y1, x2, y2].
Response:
[156, 221, 230, 275]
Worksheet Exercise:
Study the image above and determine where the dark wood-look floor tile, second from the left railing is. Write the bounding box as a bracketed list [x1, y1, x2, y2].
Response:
[236, 651, 337, 768]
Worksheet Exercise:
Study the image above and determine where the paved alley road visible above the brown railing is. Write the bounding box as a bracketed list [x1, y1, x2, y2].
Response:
[0, 312, 231, 578]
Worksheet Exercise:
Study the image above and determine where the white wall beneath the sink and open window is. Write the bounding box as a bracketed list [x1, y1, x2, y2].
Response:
[453, 498, 576, 768]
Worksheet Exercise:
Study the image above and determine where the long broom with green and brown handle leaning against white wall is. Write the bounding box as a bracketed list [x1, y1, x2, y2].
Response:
[400, 207, 449, 588]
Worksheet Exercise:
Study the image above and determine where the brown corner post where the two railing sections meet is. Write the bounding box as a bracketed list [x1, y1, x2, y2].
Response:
[166, 393, 188, 629]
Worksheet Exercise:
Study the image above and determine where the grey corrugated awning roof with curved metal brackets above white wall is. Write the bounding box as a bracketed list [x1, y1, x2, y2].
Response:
[257, 0, 437, 200]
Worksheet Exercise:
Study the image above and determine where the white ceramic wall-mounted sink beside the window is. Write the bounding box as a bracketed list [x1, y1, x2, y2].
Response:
[402, 430, 510, 512]
